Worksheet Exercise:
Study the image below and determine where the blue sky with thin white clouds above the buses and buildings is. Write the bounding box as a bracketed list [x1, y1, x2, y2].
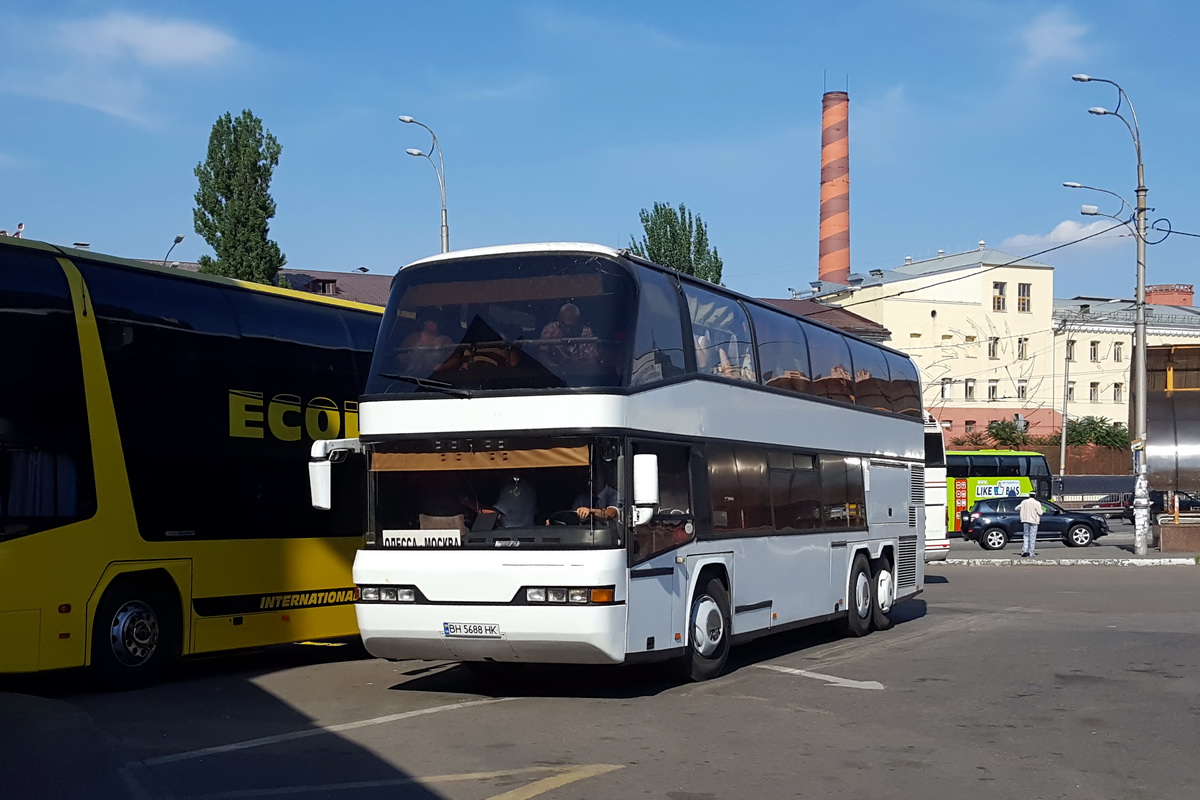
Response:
[0, 0, 1200, 303]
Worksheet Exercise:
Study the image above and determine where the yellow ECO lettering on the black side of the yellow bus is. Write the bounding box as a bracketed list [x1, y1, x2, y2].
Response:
[229, 389, 359, 441]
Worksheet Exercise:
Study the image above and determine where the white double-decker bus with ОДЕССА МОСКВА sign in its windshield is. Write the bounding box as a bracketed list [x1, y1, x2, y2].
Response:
[310, 243, 925, 680]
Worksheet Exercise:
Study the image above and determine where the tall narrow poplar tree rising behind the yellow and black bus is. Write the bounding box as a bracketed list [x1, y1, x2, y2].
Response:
[192, 108, 287, 283]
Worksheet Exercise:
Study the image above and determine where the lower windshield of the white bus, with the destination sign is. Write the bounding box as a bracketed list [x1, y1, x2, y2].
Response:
[367, 437, 625, 549]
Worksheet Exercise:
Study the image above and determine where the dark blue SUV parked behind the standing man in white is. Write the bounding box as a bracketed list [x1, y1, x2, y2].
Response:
[962, 498, 1109, 551]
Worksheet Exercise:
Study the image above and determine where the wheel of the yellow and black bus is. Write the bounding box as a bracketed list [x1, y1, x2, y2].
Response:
[91, 581, 179, 691]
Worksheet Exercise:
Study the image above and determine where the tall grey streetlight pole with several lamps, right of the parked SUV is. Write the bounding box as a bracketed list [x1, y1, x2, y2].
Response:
[1072, 74, 1150, 555]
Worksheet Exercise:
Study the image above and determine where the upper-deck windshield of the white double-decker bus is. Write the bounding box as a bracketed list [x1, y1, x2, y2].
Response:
[366, 252, 635, 395]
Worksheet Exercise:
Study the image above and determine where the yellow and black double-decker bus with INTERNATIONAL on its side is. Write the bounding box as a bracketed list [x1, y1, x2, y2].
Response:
[0, 237, 382, 687]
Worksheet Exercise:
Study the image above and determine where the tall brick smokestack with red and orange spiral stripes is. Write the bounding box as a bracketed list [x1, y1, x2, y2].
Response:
[817, 91, 850, 284]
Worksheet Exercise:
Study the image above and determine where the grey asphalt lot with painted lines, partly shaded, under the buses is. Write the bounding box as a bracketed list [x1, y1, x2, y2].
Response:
[7, 565, 1200, 800]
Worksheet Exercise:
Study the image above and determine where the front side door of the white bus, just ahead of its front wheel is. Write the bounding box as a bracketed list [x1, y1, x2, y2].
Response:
[625, 441, 696, 654]
